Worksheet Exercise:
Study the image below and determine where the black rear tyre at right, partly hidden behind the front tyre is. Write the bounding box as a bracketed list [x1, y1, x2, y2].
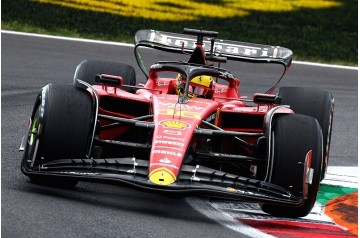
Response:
[278, 87, 334, 180]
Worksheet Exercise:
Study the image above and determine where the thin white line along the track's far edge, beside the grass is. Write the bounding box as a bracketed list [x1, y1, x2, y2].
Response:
[1, 30, 358, 70]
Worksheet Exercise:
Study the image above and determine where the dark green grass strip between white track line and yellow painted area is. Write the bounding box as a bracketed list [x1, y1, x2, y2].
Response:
[1, 0, 358, 66]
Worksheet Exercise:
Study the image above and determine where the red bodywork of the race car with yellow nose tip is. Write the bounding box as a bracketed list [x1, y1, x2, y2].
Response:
[94, 60, 292, 185]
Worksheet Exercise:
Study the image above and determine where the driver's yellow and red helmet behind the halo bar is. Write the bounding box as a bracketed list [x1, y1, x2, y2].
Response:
[175, 74, 213, 98]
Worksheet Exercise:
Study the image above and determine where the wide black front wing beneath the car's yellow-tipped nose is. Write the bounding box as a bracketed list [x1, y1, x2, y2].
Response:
[22, 157, 304, 206]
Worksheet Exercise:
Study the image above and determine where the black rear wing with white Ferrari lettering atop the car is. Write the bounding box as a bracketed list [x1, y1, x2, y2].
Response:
[135, 29, 292, 75]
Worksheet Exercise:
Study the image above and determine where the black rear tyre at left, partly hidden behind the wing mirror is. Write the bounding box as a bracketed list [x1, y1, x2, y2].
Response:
[73, 60, 136, 92]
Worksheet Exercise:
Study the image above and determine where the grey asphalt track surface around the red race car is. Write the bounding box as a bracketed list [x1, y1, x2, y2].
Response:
[1, 33, 358, 238]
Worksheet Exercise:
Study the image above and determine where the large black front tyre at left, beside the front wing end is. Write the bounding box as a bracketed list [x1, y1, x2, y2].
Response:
[21, 84, 94, 186]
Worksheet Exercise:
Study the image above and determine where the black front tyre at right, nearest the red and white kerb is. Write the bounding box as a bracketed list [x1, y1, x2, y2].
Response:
[261, 114, 322, 217]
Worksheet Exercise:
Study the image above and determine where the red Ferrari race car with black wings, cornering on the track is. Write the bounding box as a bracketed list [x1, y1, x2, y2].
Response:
[20, 28, 334, 217]
